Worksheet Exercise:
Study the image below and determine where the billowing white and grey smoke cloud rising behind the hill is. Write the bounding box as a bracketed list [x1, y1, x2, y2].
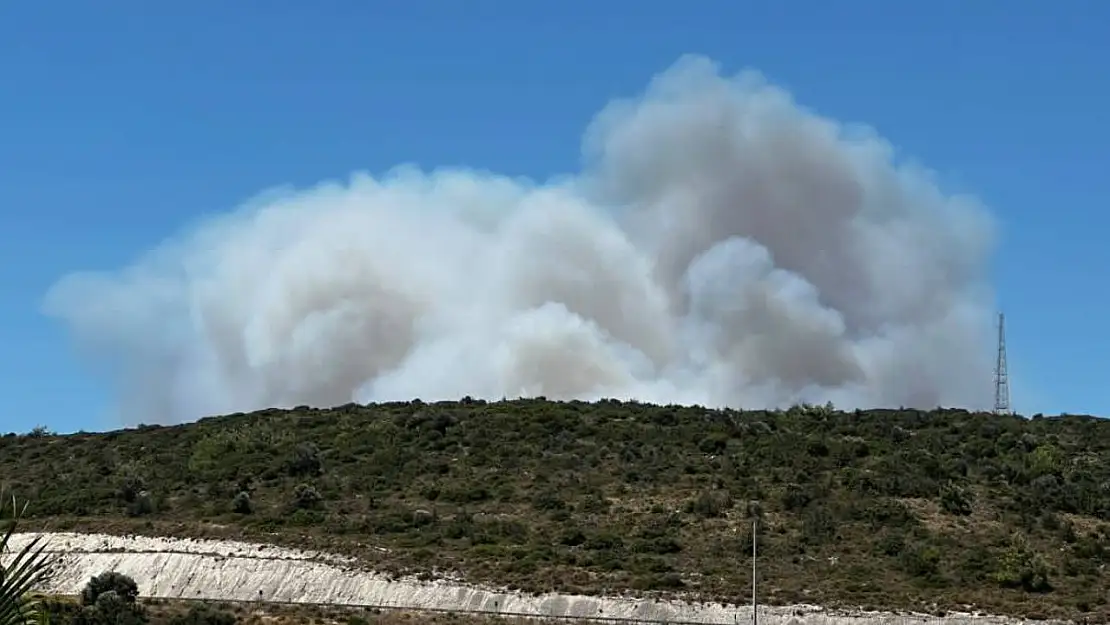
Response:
[46, 57, 992, 423]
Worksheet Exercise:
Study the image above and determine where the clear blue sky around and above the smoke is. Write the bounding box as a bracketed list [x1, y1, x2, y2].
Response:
[0, 0, 1110, 431]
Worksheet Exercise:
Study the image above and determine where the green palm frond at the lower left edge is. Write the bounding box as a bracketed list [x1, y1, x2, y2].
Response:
[0, 496, 54, 625]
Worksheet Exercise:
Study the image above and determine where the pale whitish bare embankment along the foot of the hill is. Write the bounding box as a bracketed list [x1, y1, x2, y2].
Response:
[10, 533, 1056, 625]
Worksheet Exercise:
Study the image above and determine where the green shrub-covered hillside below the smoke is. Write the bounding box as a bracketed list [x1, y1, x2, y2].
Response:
[0, 400, 1110, 619]
